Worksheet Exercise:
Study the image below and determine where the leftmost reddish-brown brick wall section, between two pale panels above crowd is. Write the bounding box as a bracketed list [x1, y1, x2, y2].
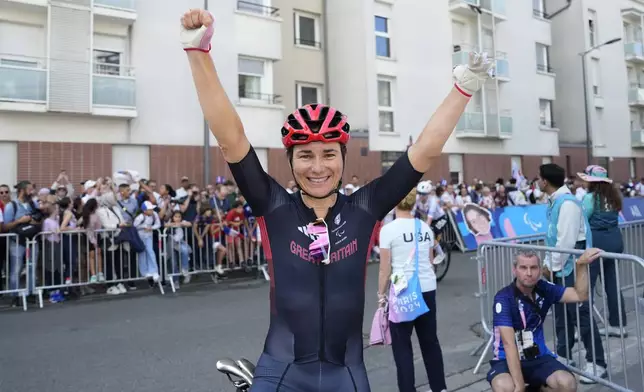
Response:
[18, 142, 112, 190]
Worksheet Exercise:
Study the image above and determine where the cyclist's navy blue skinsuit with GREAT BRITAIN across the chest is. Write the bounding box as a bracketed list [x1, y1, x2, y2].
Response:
[229, 148, 422, 392]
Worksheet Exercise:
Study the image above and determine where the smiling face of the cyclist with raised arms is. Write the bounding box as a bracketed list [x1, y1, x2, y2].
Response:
[292, 142, 344, 197]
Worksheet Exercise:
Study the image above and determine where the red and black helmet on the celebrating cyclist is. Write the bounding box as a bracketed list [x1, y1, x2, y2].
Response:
[282, 104, 351, 148]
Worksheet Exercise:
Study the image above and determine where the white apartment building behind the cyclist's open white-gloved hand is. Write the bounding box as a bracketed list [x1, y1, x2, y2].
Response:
[327, 0, 559, 180]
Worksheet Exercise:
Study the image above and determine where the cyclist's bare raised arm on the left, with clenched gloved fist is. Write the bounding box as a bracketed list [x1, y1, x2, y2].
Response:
[181, 9, 250, 163]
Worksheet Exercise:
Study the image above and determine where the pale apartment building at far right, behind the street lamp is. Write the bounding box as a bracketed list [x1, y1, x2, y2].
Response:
[546, 0, 644, 180]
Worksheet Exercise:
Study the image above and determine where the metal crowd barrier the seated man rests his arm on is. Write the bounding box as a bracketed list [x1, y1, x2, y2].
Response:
[472, 242, 644, 391]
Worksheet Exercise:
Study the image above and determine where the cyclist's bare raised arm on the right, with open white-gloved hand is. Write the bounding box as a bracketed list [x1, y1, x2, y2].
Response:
[408, 53, 493, 173]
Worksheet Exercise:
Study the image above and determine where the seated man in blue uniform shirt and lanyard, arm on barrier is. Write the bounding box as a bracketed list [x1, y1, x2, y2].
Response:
[487, 248, 601, 392]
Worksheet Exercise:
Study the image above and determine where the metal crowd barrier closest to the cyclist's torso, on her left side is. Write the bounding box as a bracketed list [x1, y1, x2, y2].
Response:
[160, 226, 262, 292]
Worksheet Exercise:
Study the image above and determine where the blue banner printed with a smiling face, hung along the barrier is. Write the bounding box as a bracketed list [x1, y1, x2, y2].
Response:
[453, 197, 644, 251]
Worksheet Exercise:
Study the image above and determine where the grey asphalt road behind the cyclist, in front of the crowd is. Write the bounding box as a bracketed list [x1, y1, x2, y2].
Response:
[0, 254, 640, 392]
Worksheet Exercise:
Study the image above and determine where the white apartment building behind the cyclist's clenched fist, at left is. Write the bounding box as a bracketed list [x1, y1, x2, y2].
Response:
[0, 0, 284, 185]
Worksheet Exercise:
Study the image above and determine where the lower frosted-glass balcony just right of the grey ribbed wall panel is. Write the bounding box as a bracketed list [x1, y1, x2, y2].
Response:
[92, 63, 137, 118]
